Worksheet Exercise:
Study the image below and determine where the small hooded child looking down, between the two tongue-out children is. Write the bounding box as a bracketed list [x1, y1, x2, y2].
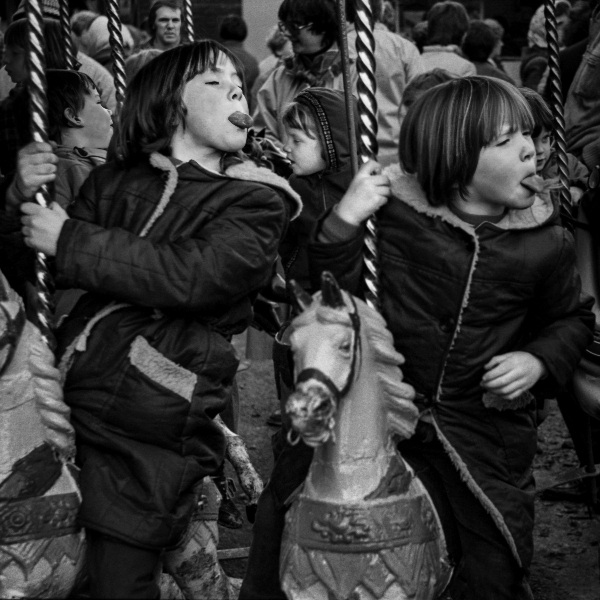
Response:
[279, 88, 358, 290]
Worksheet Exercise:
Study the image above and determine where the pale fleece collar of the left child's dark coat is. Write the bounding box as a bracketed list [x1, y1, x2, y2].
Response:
[140, 152, 302, 237]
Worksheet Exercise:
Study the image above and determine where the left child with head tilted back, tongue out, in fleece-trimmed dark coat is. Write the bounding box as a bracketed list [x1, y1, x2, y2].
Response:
[21, 41, 297, 598]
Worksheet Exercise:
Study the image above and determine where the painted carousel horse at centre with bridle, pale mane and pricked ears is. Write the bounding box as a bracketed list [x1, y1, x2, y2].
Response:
[280, 273, 452, 600]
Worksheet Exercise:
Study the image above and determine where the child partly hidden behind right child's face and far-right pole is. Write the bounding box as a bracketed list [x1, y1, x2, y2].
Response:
[520, 88, 589, 204]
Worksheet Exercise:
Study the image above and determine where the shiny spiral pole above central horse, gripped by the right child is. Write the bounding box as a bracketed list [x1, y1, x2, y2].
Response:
[356, 0, 380, 310]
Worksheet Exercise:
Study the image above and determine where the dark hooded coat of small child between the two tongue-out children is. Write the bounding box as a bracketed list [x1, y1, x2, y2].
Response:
[279, 88, 358, 290]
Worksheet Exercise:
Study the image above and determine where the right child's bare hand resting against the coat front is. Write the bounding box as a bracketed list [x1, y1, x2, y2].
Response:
[481, 352, 546, 400]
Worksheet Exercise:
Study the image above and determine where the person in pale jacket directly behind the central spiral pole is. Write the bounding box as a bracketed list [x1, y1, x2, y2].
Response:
[346, 0, 424, 167]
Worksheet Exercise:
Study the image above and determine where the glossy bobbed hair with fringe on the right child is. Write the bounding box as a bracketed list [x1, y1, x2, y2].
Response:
[400, 76, 533, 206]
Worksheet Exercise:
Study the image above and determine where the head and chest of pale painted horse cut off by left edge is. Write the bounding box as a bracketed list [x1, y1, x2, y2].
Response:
[0, 274, 85, 598]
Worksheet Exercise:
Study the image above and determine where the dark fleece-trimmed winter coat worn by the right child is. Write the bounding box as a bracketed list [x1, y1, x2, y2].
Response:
[310, 166, 594, 567]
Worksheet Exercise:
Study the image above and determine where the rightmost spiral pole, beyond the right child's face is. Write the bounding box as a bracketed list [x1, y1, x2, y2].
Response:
[544, 0, 573, 223]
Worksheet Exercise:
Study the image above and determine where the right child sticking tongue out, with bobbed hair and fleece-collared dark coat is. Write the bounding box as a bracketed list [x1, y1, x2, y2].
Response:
[309, 77, 594, 600]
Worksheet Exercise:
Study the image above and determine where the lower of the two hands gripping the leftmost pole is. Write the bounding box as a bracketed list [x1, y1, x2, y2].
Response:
[21, 202, 69, 256]
